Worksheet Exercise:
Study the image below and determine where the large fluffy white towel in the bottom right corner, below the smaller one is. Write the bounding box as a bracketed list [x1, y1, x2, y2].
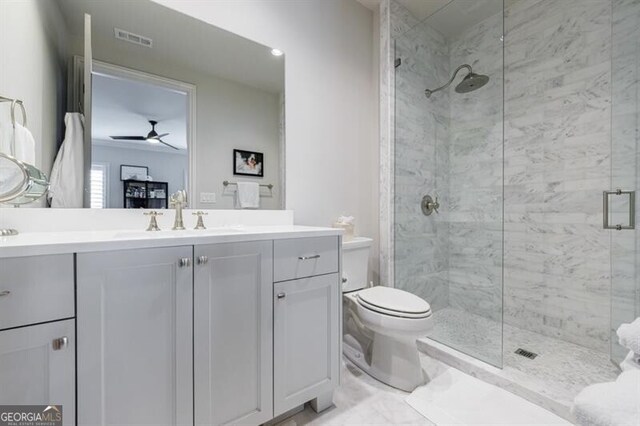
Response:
[571, 370, 640, 426]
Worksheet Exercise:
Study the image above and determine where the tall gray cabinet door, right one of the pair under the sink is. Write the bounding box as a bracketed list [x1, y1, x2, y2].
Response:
[194, 241, 273, 425]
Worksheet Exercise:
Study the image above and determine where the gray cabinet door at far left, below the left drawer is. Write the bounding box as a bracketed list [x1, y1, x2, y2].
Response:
[0, 319, 76, 425]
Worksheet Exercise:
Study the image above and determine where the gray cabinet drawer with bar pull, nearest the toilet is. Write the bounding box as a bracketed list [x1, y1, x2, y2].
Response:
[273, 237, 338, 281]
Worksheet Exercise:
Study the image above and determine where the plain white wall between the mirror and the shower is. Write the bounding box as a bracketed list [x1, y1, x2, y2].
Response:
[155, 0, 379, 282]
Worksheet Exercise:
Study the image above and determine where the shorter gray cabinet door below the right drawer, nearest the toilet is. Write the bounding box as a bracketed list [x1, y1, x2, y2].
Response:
[273, 274, 341, 416]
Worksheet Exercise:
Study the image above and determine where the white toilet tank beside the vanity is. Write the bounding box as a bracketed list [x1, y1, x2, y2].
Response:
[342, 237, 373, 292]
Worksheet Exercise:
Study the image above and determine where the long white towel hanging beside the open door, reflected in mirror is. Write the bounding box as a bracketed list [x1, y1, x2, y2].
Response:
[47, 112, 84, 208]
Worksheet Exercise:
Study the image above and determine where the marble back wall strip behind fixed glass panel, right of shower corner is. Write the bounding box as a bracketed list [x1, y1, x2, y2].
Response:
[444, 14, 503, 322]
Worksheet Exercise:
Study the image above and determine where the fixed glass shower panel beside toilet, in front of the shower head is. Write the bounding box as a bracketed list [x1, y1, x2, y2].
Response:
[394, 0, 504, 367]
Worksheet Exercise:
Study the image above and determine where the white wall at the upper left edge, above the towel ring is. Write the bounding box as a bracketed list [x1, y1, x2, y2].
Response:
[0, 0, 66, 174]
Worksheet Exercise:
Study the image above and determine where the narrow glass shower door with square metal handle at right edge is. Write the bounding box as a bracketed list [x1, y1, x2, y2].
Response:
[603, 0, 640, 363]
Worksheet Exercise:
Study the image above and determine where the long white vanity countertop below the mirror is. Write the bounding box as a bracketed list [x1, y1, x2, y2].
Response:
[0, 225, 342, 258]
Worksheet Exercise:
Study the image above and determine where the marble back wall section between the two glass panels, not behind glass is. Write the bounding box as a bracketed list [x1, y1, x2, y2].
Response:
[504, 0, 611, 351]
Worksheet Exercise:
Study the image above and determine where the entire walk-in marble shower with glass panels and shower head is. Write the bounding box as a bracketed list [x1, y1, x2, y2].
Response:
[389, 0, 640, 420]
